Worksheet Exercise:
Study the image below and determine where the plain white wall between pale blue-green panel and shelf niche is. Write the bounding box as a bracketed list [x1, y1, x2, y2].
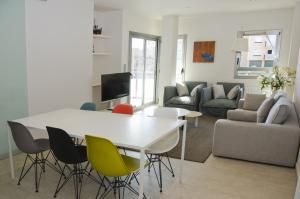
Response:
[26, 0, 94, 114]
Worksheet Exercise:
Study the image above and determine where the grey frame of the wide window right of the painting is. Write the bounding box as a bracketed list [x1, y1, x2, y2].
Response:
[234, 29, 282, 79]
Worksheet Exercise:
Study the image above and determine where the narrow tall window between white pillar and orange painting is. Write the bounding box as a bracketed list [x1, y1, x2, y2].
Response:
[176, 35, 186, 82]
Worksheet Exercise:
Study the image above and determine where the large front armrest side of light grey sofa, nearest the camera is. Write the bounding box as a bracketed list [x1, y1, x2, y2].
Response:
[213, 119, 299, 167]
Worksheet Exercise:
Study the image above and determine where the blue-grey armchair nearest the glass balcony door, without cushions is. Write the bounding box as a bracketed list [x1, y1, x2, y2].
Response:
[163, 81, 207, 111]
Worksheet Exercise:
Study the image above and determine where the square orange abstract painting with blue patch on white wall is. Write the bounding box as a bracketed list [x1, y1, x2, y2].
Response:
[193, 41, 216, 63]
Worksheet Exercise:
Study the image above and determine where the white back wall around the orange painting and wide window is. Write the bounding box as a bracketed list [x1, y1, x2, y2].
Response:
[179, 9, 293, 92]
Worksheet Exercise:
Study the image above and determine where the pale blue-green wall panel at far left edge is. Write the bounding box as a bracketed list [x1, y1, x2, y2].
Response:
[0, 0, 28, 158]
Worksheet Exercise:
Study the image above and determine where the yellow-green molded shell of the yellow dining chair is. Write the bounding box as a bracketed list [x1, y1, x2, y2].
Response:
[85, 135, 130, 177]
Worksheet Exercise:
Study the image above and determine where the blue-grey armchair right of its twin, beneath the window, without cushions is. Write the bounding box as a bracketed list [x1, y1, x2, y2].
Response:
[200, 82, 244, 118]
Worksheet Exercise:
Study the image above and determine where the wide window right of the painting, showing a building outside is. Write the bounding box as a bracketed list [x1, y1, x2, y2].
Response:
[235, 30, 281, 78]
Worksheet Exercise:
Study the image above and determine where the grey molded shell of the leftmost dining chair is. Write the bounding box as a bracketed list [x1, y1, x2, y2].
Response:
[7, 121, 40, 154]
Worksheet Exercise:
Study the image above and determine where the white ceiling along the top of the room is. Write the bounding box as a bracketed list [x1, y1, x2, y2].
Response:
[95, 0, 298, 18]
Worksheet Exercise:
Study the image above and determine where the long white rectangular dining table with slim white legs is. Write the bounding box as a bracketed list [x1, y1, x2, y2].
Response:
[8, 109, 187, 199]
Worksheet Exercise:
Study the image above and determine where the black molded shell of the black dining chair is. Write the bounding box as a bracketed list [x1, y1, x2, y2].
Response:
[46, 126, 80, 164]
